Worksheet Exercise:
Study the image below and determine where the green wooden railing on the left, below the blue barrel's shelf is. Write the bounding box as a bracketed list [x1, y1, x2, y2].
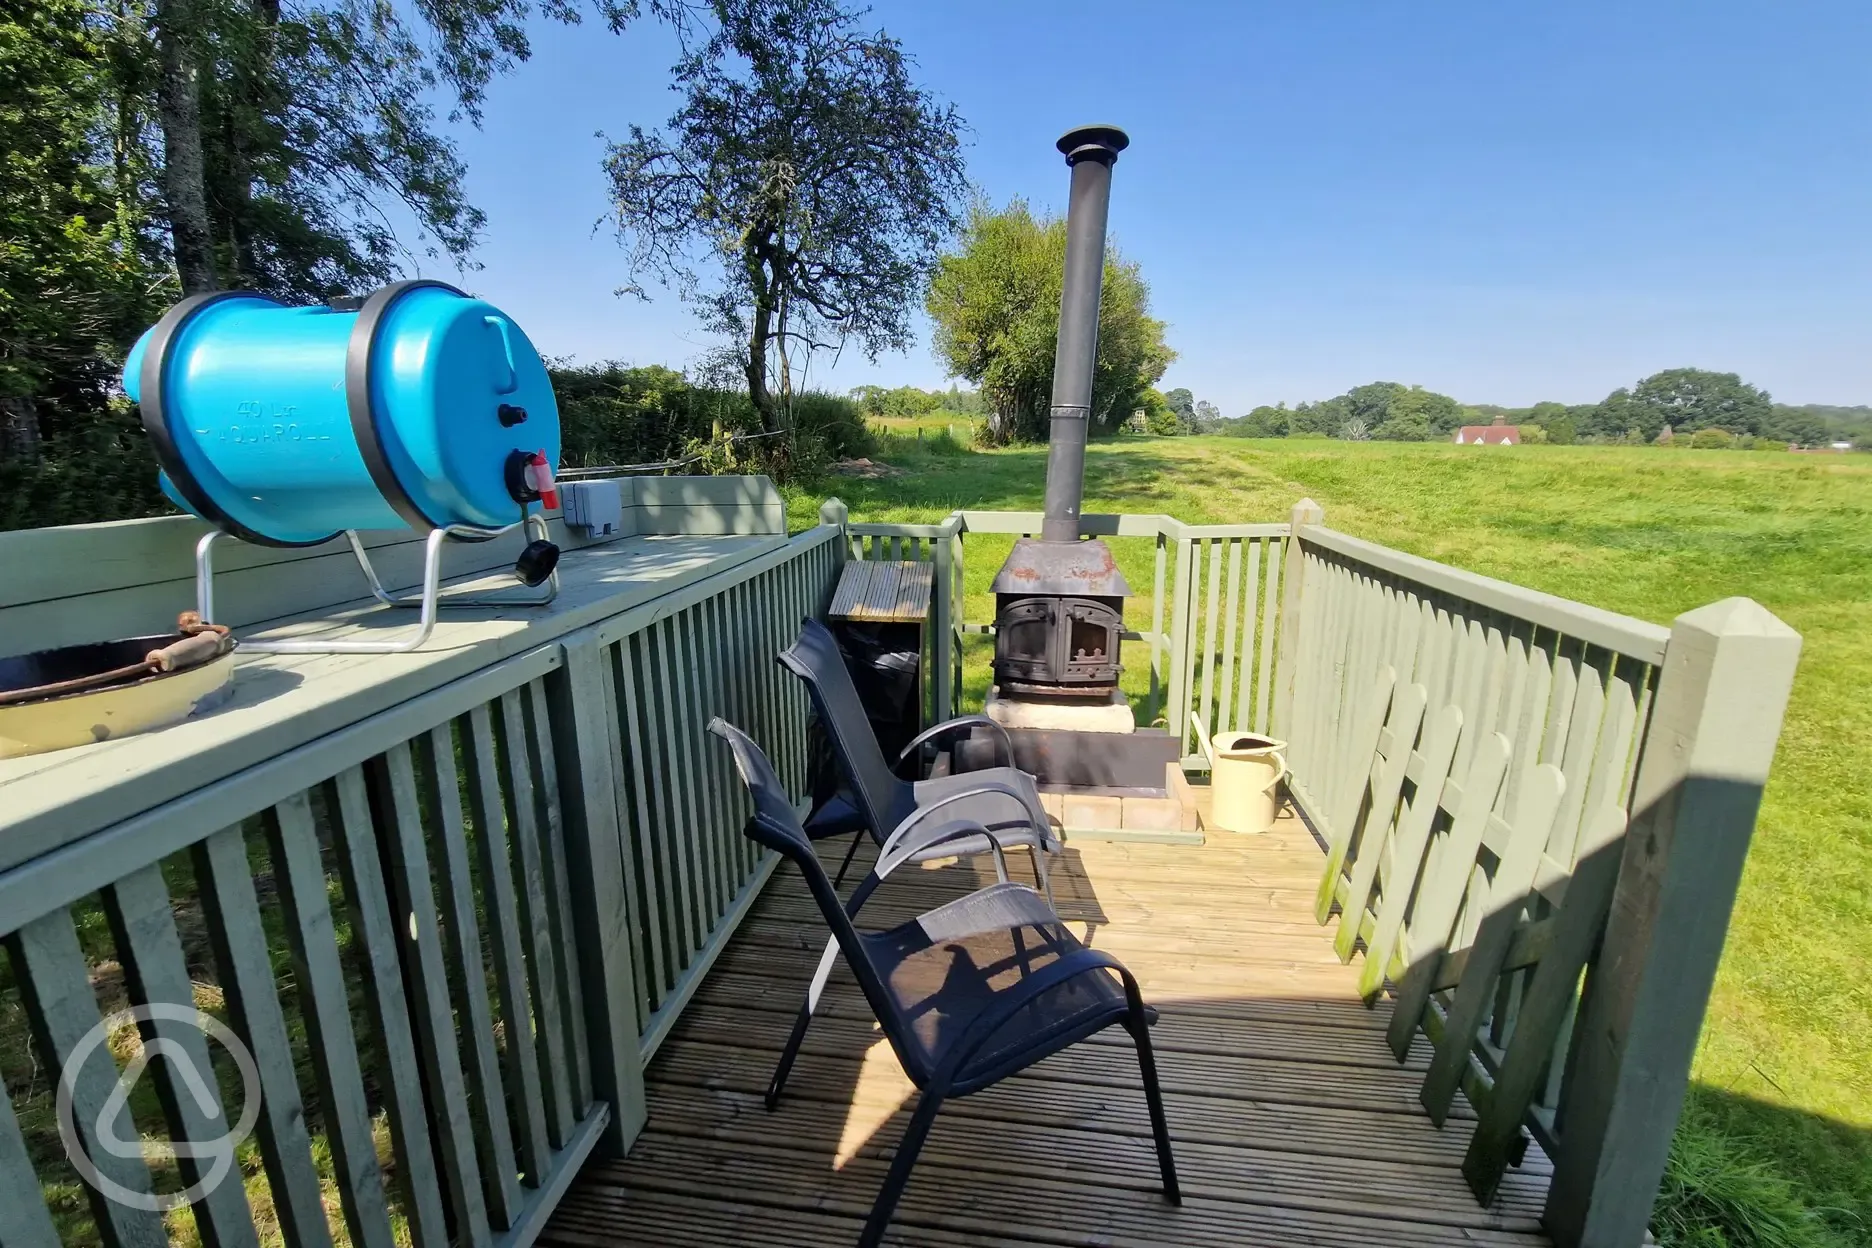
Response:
[0, 526, 844, 1248]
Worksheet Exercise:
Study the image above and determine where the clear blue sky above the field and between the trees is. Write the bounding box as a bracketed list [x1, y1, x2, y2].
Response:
[428, 0, 1872, 415]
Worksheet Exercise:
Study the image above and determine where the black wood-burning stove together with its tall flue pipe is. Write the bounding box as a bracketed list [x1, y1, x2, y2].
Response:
[994, 125, 1131, 698]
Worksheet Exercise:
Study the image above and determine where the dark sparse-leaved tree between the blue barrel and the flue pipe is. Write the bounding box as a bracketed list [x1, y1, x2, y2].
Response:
[605, 0, 964, 430]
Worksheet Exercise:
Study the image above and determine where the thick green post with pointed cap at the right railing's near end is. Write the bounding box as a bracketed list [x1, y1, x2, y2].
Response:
[1544, 599, 1801, 1248]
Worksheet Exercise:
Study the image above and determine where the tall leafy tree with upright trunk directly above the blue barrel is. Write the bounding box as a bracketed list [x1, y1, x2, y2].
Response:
[138, 0, 683, 297]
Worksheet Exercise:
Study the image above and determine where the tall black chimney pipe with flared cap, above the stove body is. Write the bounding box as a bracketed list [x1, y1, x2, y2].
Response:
[1041, 125, 1131, 541]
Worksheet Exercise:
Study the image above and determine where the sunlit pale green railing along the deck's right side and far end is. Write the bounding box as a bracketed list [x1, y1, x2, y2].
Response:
[826, 501, 1799, 1248]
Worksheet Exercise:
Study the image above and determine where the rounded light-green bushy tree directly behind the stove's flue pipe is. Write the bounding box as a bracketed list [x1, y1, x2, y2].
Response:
[925, 200, 1176, 442]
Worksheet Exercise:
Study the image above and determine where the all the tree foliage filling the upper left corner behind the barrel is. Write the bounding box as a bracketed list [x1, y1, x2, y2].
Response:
[0, 0, 681, 473]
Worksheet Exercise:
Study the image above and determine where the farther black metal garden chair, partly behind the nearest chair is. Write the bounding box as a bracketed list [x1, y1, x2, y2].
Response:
[779, 617, 1063, 902]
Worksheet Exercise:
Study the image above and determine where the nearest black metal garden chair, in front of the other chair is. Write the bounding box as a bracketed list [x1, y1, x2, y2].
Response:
[709, 718, 1183, 1248]
